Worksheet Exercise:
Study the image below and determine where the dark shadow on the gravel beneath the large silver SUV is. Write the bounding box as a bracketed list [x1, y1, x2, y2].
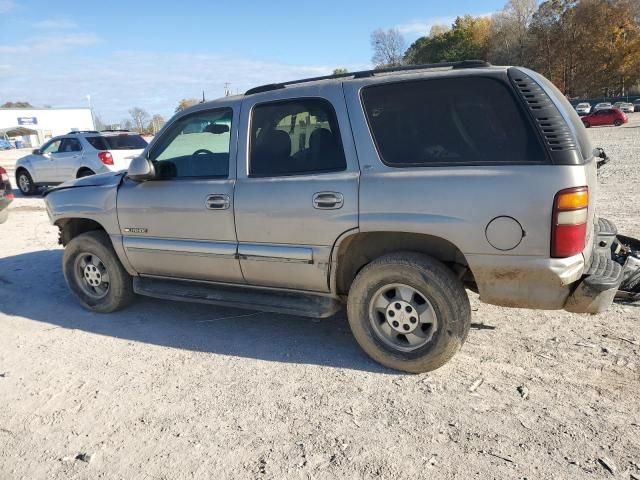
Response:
[0, 249, 390, 374]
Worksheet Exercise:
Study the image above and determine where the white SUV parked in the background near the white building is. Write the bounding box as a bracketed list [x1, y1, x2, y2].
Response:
[16, 130, 147, 195]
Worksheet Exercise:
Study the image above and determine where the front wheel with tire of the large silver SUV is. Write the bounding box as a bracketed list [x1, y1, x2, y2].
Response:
[62, 231, 134, 313]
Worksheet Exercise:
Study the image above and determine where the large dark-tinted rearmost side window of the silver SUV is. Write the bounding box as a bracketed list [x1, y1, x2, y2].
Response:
[362, 77, 546, 167]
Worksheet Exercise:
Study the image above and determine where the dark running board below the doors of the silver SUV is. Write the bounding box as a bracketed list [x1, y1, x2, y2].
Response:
[133, 277, 342, 318]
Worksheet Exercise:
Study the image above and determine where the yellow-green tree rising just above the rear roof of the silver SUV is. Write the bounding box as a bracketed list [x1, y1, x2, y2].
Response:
[405, 15, 491, 64]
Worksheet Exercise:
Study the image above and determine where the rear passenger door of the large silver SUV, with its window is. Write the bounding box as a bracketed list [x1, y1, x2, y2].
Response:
[235, 83, 359, 292]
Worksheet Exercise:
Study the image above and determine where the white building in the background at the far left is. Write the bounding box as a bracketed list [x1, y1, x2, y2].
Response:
[0, 108, 95, 147]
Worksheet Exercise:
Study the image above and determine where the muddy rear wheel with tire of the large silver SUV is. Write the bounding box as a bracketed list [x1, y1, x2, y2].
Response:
[347, 252, 471, 373]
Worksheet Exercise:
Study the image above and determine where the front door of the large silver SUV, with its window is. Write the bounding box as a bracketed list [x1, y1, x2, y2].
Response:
[117, 104, 242, 283]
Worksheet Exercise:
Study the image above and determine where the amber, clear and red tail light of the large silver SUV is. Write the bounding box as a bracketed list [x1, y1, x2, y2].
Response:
[551, 187, 589, 258]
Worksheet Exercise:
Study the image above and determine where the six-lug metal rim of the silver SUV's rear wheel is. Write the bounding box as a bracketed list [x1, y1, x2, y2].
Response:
[369, 283, 438, 352]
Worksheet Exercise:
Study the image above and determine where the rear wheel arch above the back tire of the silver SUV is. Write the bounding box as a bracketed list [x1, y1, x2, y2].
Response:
[329, 230, 472, 295]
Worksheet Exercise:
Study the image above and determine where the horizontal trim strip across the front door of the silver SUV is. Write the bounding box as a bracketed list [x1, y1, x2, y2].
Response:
[122, 237, 237, 258]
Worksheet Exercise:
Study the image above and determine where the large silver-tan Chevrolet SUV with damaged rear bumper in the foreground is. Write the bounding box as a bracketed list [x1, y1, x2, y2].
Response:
[46, 61, 627, 372]
